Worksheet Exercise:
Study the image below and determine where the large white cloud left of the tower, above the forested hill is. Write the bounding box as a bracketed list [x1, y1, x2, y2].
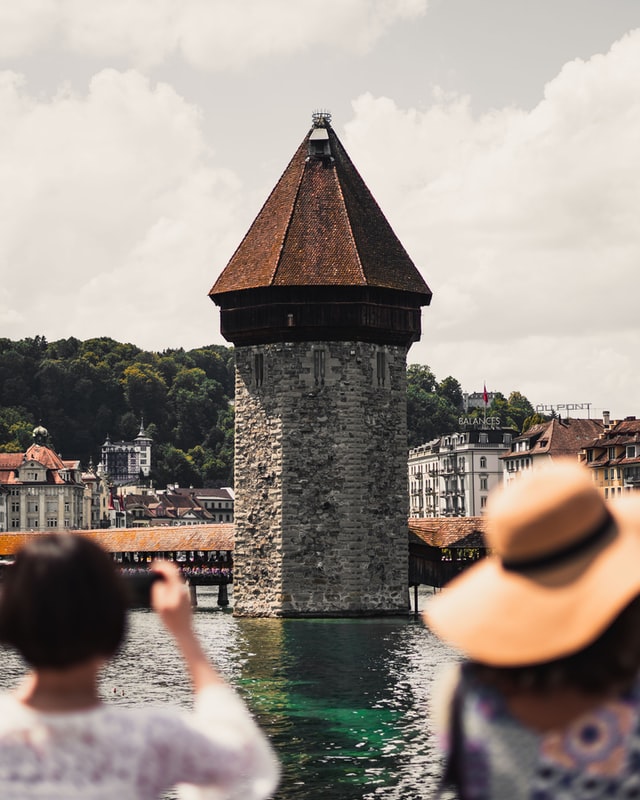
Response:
[0, 70, 241, 348]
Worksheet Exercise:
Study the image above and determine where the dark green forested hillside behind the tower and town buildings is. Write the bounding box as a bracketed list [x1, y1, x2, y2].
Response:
[0, 336, 535, 486]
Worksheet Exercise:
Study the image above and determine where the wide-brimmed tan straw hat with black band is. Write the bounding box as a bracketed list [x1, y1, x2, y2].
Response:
[424, 460, 640, 666]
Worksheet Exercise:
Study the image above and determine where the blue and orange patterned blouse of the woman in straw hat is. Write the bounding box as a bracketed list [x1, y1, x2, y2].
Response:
[444, 668, 640, 800]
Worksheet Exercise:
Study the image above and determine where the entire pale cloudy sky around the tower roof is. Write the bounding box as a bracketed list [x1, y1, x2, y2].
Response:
[0, 0, 640, 418]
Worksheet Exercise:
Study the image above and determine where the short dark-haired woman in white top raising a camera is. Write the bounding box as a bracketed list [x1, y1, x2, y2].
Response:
[0, 534, 279, 800]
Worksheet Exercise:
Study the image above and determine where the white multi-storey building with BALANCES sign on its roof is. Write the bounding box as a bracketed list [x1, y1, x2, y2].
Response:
[409, 427, 515, 517]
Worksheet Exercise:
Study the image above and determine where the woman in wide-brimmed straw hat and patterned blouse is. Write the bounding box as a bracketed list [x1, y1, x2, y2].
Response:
[424, 461, 640, 800]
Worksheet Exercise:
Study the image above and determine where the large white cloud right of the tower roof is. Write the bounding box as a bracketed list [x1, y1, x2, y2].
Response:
[345, 30, 640, 413]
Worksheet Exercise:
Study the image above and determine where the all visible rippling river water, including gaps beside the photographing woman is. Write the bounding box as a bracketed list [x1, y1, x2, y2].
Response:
[0, 590, 451, 800]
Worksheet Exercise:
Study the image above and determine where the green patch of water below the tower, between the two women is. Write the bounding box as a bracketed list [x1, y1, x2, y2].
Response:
[232, 608, 449, 800]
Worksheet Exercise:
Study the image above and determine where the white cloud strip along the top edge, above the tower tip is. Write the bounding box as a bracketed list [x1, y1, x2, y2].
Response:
[0, 0, 427, 70]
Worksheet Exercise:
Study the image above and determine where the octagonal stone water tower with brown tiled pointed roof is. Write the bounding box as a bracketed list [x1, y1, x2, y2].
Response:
[210, 112, 431, 617]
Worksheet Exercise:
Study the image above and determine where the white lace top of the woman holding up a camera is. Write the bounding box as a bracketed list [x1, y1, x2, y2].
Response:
[0, 685, 279, 800]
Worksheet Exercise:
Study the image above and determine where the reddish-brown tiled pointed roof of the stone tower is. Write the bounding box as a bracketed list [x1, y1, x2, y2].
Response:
[209, 116, 431, 305]
